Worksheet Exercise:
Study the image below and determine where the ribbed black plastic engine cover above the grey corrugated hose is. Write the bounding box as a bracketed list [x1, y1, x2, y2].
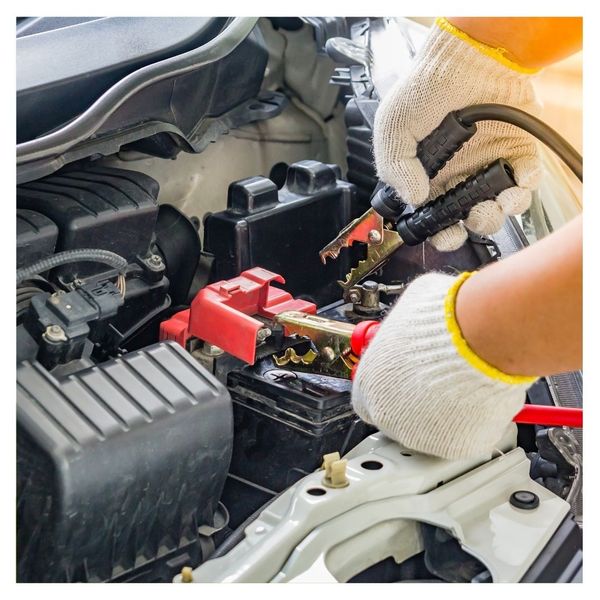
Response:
[17, 167, 159, 281]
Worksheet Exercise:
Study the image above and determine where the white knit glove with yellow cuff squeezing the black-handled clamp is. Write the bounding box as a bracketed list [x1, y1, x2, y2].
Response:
[373, 19, 541, 251]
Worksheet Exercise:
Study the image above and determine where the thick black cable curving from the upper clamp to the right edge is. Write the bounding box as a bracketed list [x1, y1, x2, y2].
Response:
[457, 104, 583, 181]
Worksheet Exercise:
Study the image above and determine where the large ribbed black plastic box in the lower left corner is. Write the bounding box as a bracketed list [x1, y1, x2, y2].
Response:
[17, 342, 233, 582]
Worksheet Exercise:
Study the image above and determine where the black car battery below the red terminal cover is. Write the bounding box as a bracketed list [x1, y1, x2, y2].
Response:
[222, 357, 374, 526]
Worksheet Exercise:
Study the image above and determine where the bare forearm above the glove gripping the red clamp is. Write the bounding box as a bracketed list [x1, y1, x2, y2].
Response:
[456, 216, 582, 376]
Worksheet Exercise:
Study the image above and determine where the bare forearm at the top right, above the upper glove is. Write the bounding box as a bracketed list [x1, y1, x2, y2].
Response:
[447, 17, 583, 69]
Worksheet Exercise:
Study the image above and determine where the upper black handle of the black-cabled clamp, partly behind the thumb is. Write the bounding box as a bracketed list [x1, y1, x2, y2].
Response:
[371, 111, 477, 220]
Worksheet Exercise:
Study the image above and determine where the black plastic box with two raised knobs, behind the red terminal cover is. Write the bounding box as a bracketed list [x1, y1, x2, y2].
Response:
[204, 160, 357, 306]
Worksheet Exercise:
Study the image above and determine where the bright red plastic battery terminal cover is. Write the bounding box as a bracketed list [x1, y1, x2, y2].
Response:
[160, 267, 317, 364]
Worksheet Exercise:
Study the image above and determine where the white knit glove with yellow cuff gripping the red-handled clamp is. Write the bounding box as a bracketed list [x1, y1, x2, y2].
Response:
[352, 273, 536, 459]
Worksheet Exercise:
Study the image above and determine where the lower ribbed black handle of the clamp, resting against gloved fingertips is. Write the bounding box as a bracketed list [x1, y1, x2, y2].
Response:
[396, 158, 517, 246]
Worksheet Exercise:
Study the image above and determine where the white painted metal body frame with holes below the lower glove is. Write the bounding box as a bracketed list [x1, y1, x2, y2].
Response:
[184, 426, 569, 583]
